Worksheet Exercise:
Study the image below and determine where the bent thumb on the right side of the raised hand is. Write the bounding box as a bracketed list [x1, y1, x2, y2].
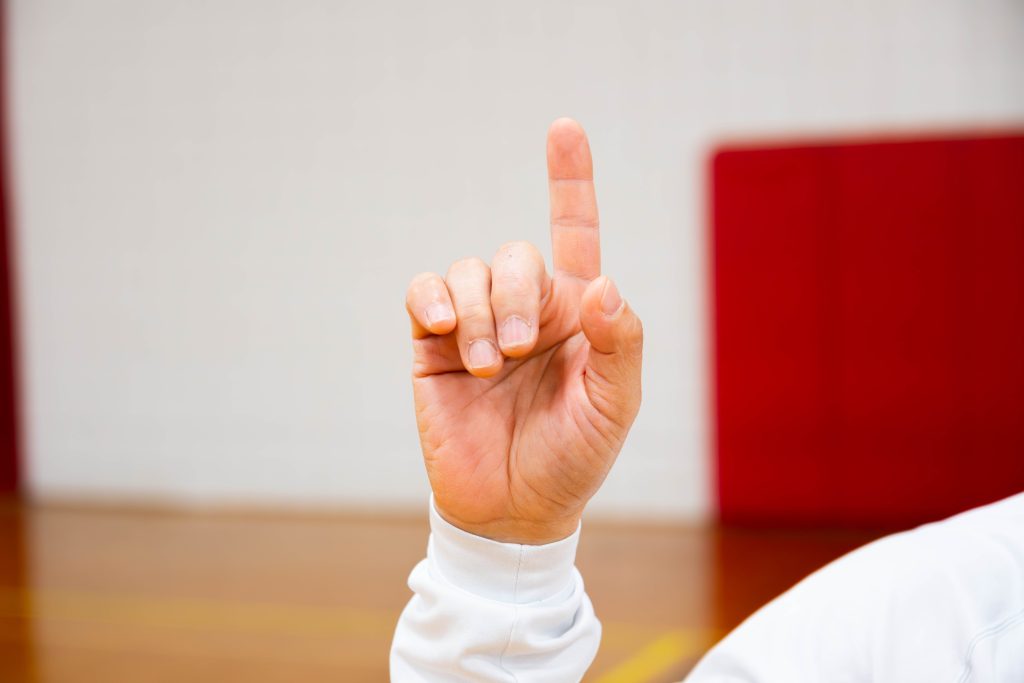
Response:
[580, 275, 643, 428]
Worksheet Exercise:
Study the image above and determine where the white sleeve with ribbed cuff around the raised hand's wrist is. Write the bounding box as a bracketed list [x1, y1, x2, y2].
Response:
[391, 505, 601, 683]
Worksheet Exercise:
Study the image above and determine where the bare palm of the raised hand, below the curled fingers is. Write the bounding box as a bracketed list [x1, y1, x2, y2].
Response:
[414, 275, 617, 523]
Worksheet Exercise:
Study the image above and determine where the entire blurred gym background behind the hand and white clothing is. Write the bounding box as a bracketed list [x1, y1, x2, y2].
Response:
[0, 0, 1024, 681]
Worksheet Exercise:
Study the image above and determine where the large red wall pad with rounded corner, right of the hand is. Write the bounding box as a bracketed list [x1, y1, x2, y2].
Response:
[712, 134, 1024, 525]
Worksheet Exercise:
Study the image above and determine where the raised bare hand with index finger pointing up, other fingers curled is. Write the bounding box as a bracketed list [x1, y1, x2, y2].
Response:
[406, 119, 643, 544]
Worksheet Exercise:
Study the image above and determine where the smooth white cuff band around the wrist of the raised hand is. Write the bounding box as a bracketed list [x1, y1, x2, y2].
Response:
[427, 498, 580, 604]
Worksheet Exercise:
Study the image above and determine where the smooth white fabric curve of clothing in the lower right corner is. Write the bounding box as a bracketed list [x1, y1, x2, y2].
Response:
[687, 494, 1024, 683]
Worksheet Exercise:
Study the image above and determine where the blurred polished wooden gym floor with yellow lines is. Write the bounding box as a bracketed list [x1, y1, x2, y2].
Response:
[0, 502, 877, 683]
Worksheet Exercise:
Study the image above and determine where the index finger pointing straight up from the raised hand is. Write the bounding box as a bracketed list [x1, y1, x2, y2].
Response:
[548, 119, 601, 280]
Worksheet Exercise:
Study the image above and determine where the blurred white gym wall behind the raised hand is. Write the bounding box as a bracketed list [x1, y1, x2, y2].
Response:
[8, 0, 1024, 517]
